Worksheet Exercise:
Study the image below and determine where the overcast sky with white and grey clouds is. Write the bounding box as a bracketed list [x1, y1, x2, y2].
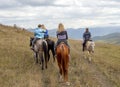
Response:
[0, 0, 120, 29]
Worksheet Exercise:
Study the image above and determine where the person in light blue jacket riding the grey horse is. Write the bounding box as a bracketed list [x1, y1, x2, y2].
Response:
[31, 24, 46, 50]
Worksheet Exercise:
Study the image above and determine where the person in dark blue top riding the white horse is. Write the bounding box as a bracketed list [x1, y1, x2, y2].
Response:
[83, 28, 91, 51]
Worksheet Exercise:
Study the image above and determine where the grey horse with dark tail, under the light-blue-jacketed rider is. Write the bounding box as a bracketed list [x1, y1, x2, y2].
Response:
[33, 39, 48, 70]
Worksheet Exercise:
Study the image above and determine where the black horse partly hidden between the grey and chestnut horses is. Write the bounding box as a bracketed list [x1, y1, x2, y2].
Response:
[46, 38, 55, 62]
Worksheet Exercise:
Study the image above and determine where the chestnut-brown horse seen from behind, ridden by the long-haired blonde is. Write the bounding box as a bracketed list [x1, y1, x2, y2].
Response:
[56, 42, 69, 85]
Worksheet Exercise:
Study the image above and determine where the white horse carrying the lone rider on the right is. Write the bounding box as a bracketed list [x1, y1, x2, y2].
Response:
[85, 41, 95, 62]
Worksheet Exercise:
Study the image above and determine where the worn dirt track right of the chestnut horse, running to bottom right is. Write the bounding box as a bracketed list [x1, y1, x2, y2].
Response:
[73, 45, 113, 87]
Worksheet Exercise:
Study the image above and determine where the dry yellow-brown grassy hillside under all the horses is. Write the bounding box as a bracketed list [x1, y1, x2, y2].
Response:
[0, 26, 120, 87]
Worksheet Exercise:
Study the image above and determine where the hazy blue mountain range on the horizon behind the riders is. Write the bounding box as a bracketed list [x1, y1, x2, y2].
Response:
[28, 26, 120, 39]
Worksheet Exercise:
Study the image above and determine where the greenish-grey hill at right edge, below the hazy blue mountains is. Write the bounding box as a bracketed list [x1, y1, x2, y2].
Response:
[93, 33, 120, 44]
